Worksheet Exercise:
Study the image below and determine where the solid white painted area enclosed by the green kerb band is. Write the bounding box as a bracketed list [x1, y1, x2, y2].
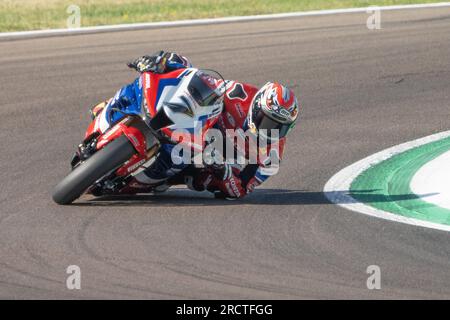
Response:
[410, 151, 450, 210]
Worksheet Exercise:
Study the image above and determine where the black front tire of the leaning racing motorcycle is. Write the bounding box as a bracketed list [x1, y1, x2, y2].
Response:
[53, 135, 136, 205]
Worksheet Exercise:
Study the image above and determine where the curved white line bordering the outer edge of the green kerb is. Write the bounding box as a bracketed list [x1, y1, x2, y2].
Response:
[324, 131, 450, 231]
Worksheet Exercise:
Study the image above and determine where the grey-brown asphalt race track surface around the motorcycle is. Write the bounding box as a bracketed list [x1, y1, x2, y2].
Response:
[0, 8, 450, 299]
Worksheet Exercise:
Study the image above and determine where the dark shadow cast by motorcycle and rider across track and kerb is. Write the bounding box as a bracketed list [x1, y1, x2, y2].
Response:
[73, 188, 429, 207]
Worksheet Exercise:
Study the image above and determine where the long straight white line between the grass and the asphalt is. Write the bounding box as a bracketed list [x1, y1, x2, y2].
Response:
[0, 2, 450, 40]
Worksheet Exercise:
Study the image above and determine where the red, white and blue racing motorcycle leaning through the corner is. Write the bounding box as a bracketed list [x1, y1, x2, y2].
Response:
[53, 68, 225, 204]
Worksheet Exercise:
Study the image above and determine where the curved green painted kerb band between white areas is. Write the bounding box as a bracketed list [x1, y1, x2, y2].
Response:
[350, 137, 450, 225]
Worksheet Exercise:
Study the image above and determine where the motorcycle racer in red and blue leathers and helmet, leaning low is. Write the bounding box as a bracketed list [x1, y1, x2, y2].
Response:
[91, 51, 299, 199]
